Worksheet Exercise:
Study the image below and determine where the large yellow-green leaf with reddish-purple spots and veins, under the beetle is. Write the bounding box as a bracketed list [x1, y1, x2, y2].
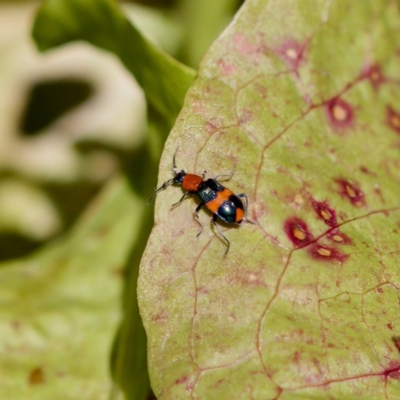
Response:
[138, 0, 400, 400]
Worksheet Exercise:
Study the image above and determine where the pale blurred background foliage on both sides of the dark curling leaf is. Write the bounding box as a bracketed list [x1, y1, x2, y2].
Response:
[0, 0, 241, 261]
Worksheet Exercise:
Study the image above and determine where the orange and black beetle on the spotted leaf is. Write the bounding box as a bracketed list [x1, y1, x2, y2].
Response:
[148, 148, 254, 255]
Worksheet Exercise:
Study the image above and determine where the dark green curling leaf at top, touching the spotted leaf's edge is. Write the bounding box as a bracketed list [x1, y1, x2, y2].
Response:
[33, 0, 195, 134]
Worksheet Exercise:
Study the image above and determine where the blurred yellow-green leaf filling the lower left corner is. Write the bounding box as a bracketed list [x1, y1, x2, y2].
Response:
[0, 179, 143, 400]
